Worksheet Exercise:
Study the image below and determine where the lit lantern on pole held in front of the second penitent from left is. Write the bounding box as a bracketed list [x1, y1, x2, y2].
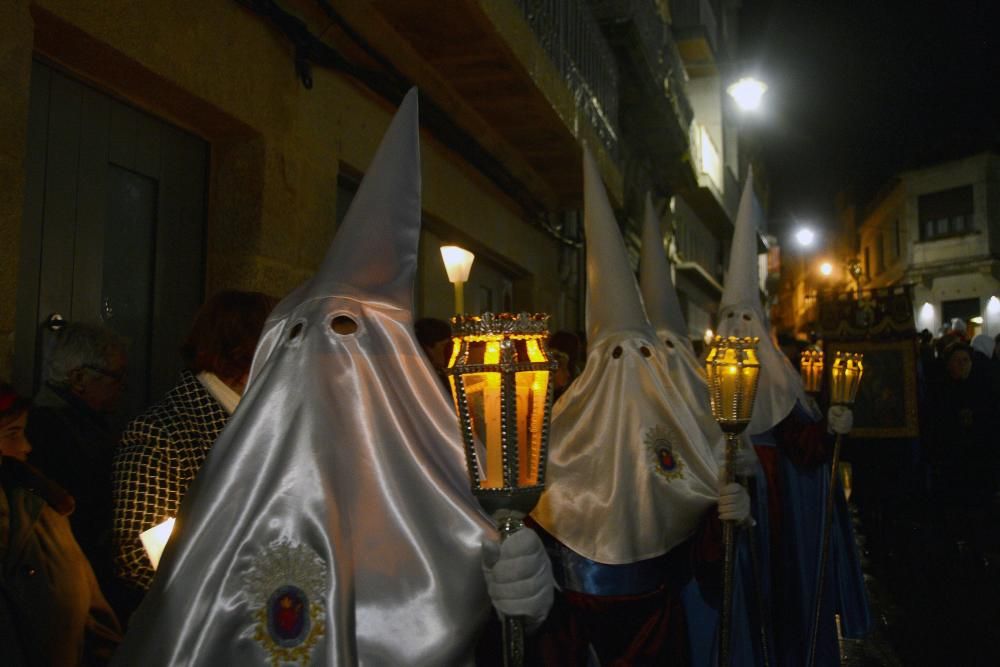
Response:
[705, 336, 760, 667]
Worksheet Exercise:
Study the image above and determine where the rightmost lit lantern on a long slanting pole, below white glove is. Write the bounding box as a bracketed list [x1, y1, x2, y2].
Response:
[808, 352, 864, 667]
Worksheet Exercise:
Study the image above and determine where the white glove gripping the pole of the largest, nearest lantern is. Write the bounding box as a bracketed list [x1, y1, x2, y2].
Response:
[483, 528, 555, 632]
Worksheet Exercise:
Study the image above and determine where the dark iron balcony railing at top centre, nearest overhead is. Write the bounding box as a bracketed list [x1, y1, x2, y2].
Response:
[514, 0, 619, 161]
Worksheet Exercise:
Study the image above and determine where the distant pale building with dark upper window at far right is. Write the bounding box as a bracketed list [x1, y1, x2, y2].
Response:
[857, 152, 1000, 335]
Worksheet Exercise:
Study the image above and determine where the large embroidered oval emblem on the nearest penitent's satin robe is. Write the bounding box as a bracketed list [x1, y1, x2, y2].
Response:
[243, 542, 328, 667]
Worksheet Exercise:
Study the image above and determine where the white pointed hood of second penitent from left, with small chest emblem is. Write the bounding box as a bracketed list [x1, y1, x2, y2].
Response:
[533, 152, 718, 564]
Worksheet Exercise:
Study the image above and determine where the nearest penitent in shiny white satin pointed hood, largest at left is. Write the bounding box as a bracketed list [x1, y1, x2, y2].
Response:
[117, 90, 494, 666]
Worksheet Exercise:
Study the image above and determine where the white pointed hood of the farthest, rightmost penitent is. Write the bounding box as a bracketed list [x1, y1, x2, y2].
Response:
[718, 172, 819, 435]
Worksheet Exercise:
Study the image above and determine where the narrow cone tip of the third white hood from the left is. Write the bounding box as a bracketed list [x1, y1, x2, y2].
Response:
[639, 192, 687, 339]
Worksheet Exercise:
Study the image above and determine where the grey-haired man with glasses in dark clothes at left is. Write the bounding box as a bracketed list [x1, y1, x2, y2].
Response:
[27, 323, 126, 595]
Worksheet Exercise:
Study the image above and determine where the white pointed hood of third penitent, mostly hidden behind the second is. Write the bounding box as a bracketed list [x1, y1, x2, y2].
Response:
[639, 194, 725, 464]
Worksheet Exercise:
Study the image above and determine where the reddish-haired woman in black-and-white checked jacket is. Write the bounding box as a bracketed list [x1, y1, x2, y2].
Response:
[113, 291, 276, 604]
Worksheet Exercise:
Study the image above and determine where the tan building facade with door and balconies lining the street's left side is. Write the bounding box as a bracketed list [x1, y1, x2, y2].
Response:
[0, 0, 752, 418]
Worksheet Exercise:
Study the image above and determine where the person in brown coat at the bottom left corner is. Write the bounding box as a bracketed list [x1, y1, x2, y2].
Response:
[0, 383, 121, 667]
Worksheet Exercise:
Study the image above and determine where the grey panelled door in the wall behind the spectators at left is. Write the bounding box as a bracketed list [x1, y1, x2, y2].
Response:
[14, 62, 208, 416]
